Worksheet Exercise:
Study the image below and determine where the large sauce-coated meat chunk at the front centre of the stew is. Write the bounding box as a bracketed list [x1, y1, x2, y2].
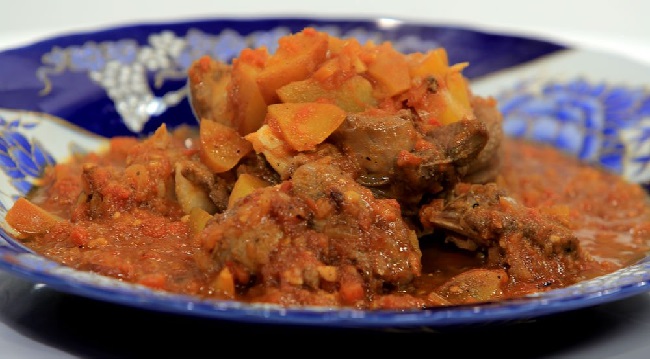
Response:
[201, 158, 421, 307]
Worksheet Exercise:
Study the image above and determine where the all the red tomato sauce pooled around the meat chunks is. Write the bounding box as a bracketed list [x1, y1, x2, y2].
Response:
[8, 130, 650, 307]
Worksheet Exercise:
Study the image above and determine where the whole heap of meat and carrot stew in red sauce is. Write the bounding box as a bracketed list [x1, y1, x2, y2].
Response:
[6, 28, 650, 309]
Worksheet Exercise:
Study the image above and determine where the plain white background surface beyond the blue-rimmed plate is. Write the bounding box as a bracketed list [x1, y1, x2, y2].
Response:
[0, 0, 650, 358]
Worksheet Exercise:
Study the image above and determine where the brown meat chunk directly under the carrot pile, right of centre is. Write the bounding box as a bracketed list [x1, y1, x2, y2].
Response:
[331, 110, 488, 214]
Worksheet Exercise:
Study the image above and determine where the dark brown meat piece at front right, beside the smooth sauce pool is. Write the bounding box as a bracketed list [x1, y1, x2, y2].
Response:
[420, 183, 587, 288]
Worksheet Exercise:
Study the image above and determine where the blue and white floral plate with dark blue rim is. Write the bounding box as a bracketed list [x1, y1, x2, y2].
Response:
[0, 18, 650, 328]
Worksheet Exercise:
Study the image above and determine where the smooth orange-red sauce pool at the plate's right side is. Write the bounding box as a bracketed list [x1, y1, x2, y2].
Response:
[501, 141, 650, 275]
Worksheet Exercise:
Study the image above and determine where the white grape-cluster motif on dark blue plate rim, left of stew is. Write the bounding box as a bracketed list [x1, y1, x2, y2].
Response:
[38, 31, 191, 133]
